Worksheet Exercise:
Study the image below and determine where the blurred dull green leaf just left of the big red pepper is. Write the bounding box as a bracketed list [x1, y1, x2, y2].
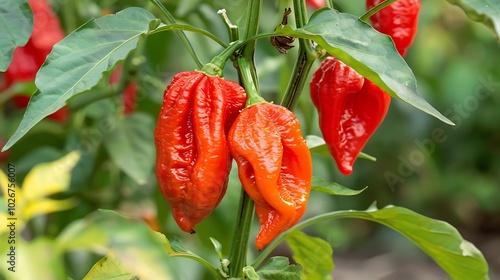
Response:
[103, 113, 156, 185]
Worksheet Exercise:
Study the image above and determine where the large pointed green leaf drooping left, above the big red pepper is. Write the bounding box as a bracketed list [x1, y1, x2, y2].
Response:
[3, 8, 160, 150]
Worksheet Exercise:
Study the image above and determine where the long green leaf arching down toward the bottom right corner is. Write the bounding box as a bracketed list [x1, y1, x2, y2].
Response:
[293, 206, 489, 280]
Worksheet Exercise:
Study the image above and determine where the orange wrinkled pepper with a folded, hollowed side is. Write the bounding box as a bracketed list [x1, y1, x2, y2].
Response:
[228, 103, 312, 250]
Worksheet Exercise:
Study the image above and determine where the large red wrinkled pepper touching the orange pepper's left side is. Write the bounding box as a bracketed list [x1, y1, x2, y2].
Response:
[154, 71, 246, 233]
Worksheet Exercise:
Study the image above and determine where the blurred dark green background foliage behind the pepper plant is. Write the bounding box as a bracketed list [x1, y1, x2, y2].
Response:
[0, 0, 500, 279]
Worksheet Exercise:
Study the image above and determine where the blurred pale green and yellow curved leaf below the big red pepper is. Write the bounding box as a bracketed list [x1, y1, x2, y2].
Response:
[56, 210, 175, 280]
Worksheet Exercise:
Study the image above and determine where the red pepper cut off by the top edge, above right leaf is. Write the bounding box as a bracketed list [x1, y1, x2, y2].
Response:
[366, 0, 420, 56]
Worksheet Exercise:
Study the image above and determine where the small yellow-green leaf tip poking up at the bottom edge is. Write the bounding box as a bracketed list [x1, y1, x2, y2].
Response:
[83, 255, 136, 280]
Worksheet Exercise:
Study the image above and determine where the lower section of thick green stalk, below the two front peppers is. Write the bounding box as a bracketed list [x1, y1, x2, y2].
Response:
[229, 189, 254, 277]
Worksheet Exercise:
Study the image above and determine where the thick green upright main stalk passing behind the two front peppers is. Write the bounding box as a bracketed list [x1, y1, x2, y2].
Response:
[229, 0, 262, 278]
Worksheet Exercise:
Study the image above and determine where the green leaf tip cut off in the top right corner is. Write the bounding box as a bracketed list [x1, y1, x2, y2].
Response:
[448, 0, 500, 39]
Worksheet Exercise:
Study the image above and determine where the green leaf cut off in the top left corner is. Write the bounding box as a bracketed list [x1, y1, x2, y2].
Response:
[0, 0, 33, 71]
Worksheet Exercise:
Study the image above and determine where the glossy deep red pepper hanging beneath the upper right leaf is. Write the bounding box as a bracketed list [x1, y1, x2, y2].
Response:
[310, 57, 391, 175]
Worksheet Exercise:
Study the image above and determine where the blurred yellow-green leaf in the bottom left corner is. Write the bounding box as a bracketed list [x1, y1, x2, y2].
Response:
[0, 237, 66, 280]
